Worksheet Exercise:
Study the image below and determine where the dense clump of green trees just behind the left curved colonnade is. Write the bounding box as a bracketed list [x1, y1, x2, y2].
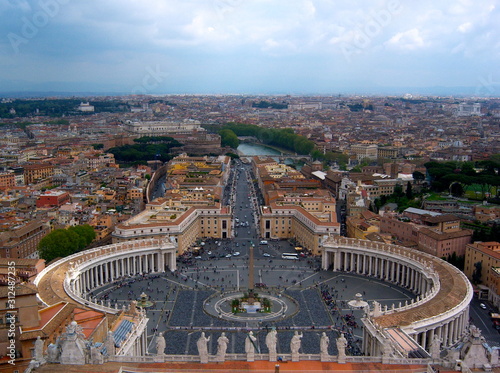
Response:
[38, 224, 95, 263]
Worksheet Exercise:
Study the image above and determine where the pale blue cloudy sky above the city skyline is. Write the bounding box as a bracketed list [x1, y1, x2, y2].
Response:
[0, 0, 500, 96]
